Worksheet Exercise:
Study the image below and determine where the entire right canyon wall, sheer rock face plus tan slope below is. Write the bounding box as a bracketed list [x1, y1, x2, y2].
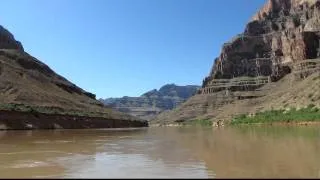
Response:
[154, 0, 320, 123]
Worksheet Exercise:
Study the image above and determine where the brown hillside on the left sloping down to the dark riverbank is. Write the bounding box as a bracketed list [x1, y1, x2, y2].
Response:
[0, 26, 145, 125]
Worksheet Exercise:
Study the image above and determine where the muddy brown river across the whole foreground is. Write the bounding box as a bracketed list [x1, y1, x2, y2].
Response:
[0, 126, 320, 178]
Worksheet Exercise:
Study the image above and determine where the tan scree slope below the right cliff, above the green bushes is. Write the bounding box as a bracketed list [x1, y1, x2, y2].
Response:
[152, 73, 320, 124]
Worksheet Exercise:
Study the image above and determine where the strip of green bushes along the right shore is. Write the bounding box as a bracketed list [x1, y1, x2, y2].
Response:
[230, 104, 320, 125]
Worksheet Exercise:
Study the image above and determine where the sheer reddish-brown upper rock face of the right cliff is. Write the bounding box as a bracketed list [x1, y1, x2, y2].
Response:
[203, 0, 320, 86]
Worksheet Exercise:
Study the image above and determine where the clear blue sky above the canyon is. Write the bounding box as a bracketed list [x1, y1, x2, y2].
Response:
[0, 0, 264, 98]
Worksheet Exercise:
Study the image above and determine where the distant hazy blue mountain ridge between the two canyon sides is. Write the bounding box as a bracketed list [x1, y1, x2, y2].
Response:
[100, 84, 200, 120]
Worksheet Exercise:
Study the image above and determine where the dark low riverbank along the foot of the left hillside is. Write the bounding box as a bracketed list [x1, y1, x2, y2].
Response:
[0, 110, 149, 131]
